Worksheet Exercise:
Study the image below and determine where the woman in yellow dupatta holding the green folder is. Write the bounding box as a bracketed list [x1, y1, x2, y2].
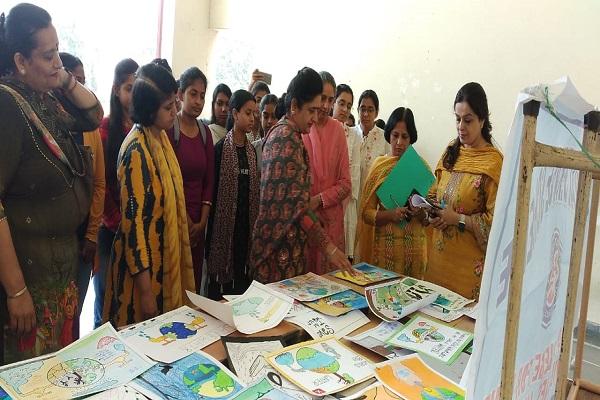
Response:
[355, 107, 427, 279]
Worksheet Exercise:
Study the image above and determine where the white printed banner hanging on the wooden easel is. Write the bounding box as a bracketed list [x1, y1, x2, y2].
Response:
[467, 78, 593, 400]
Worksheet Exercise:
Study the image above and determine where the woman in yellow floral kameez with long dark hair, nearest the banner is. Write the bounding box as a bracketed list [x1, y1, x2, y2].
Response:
[425, 82, 502, 300]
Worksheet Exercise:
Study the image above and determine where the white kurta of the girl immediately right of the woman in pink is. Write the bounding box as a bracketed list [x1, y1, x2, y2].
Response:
[344, 125, 362, 258]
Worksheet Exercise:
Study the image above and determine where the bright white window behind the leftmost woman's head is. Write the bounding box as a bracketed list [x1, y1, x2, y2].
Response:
[3, 0, 160, 108]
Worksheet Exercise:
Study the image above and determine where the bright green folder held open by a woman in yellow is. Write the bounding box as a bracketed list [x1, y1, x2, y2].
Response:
[377, 146, 435, 210]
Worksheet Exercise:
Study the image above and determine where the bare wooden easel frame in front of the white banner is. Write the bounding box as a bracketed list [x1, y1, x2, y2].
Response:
[500, 100, 600, 400]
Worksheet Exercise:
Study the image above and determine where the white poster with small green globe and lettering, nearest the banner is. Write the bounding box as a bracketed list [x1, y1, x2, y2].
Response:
[386, 315, 473, 365]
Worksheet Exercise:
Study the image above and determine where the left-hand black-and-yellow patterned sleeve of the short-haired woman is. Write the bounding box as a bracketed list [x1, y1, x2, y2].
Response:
[118, 143, 157, 275]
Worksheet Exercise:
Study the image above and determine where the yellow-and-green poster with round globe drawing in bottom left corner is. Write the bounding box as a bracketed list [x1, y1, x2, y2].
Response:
[0, 323, 154, 400]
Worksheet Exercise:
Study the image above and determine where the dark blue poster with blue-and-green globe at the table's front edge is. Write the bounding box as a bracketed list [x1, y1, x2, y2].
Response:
[130, 352, 243, 400]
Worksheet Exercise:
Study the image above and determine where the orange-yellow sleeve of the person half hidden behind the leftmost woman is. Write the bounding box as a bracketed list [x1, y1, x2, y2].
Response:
[83, 129, 106, 243]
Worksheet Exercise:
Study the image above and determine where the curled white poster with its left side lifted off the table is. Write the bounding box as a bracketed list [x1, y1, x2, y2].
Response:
[188, 281, 294, 335]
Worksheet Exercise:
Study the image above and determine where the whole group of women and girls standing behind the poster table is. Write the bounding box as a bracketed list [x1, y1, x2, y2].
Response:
[0, 4, 502, 363]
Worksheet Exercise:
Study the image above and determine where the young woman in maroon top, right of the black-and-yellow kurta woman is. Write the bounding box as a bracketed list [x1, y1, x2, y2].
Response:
[168, 67, 215, 292]
